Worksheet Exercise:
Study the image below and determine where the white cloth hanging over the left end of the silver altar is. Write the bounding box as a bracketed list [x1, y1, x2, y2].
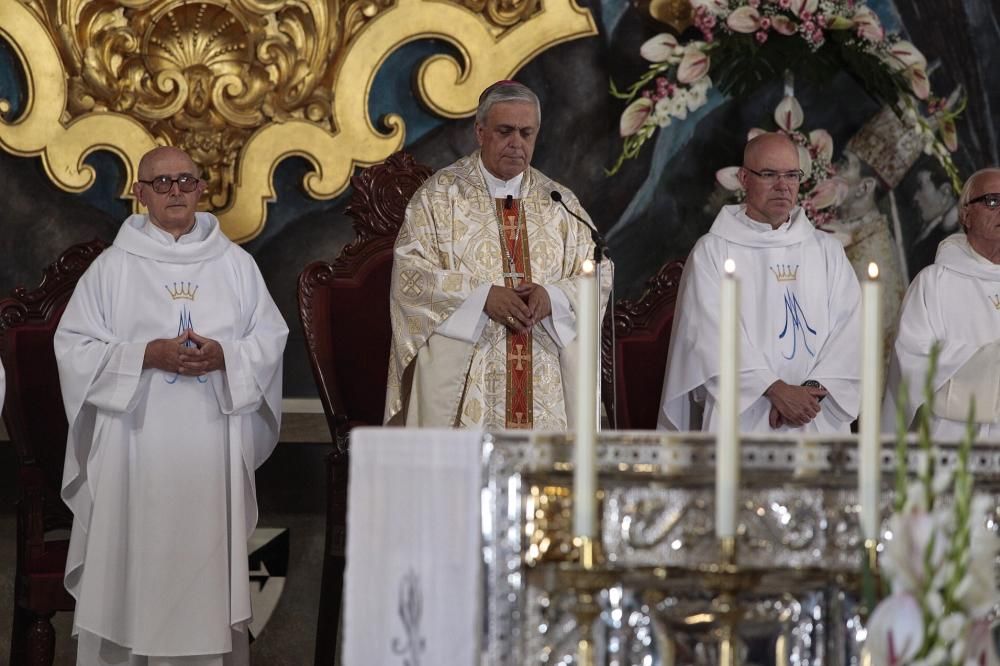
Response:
[343, 428, 483, 666]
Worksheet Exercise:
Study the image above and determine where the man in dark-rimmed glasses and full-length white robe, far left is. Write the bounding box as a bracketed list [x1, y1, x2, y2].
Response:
[55, 147, 288, 666]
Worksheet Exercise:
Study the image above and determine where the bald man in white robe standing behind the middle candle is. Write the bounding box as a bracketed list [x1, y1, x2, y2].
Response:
[659, 134, 860, 433]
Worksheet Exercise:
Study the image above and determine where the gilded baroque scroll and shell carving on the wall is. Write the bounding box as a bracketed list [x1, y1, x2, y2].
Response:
[0, 0, 596, 241]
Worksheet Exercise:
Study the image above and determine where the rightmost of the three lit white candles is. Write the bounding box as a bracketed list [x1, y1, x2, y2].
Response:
[858, 262, 882, 539]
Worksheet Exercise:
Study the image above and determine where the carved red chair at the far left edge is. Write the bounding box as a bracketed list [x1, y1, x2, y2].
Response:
[0, 240, 107, 666]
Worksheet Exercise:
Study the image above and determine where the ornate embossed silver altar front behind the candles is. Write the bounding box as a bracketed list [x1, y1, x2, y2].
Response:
[482, 432, 1000, 666]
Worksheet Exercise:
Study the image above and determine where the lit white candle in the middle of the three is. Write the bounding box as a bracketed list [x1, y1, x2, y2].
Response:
[715, 259, 740, 539]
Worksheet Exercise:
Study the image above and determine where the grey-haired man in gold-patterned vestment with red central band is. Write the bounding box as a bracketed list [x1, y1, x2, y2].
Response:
[385, 81, 612, 430]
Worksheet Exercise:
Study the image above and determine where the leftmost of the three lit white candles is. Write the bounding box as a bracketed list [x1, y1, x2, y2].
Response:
[573, 259, 599, 538]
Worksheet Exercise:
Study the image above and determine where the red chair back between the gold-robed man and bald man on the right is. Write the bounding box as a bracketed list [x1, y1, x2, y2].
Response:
[601, 261, 684, 430]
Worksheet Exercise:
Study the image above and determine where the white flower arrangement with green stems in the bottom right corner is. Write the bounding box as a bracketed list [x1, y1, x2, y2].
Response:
[865, 349, 1000, 666]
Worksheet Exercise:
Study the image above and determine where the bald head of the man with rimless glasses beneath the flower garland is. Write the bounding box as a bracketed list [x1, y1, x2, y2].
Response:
[737, 132, 802, 229]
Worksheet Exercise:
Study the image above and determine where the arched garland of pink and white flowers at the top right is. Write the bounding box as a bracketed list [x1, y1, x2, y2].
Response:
[608, 0, 964, 191]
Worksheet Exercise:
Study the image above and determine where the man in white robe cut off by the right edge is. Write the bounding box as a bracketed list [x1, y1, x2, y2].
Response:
[883, 168, 1000, 441]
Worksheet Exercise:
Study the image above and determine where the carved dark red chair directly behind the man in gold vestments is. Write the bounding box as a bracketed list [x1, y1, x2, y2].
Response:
[298, 152, 431, 666]
